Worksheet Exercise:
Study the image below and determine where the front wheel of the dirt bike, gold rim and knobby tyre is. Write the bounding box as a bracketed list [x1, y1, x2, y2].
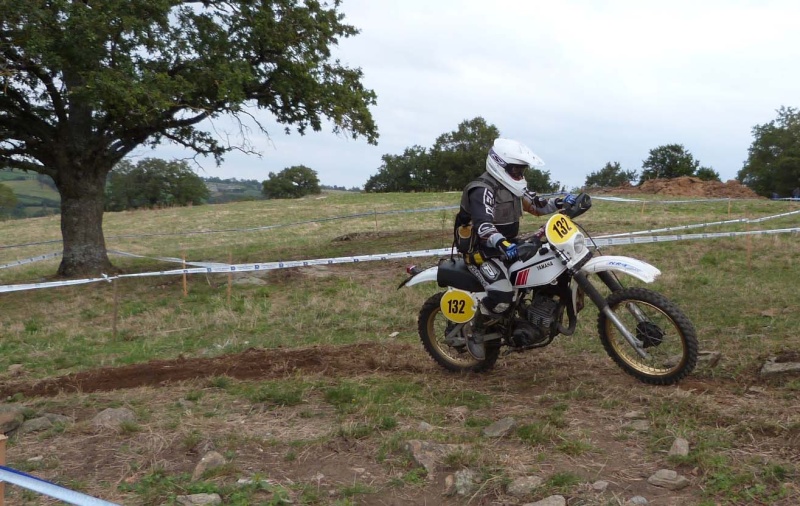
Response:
[597, 288, 697, 385]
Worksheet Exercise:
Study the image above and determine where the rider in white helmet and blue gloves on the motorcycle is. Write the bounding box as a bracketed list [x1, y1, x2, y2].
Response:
[456, 138, 575, 358]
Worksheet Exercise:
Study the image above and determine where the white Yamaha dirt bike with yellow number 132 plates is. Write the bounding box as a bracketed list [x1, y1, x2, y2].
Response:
[398, 194, 698, 385]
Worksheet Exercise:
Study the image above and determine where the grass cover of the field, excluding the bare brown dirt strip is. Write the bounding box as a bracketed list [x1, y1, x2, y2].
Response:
[0, 193, 800, 504]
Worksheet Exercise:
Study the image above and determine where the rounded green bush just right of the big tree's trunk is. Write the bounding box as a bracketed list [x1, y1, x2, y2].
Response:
[106, 158, 209, 211]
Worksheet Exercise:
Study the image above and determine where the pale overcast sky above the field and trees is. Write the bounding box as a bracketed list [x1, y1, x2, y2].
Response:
[141, 0, 800, 188]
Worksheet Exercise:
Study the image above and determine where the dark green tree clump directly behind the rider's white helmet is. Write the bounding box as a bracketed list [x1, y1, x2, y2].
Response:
[364, 117, 559, 192]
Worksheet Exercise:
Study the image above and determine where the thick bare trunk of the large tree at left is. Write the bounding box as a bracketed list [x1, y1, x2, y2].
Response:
[55, 167, 111, 277]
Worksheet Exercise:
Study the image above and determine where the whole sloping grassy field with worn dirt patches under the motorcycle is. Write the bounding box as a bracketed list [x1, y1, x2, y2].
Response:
[0, 192, 800, 505]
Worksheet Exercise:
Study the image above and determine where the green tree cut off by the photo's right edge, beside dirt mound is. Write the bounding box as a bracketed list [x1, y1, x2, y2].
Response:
[737, 107, 800, 197]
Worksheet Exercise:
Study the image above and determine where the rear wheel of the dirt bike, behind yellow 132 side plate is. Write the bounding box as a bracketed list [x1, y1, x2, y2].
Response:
[417, 292, 500, 372]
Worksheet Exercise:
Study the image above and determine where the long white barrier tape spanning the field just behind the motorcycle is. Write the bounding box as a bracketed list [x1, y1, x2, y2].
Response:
[6, 227, 800, 293]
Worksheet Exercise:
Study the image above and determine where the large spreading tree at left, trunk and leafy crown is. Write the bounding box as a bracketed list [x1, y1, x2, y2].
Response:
[0, 0, 377, 276]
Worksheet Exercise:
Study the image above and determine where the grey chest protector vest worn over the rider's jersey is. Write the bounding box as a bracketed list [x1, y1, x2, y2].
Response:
[453, 172, 522, 254]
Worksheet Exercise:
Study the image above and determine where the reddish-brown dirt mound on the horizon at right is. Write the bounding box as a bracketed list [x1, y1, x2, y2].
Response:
[603, 176, 763, 199]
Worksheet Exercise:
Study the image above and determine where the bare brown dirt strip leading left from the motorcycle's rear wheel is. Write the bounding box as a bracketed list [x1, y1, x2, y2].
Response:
[0, 343, 432, 398]
